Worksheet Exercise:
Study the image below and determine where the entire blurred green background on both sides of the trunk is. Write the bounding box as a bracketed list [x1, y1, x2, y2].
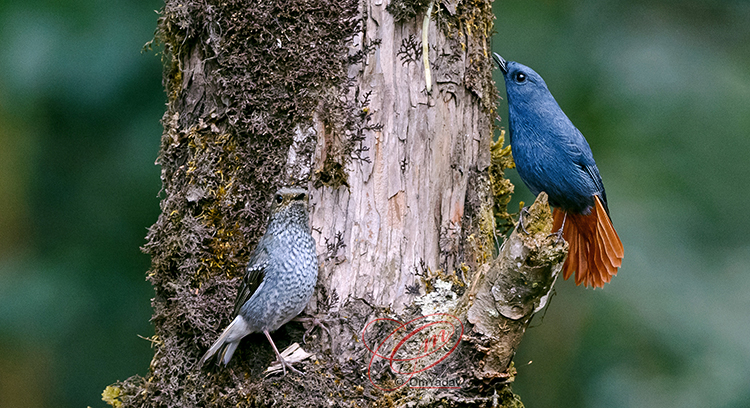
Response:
[0, 0, 750, 408]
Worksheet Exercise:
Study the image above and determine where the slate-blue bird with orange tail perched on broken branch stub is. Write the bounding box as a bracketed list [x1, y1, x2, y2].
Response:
[493, 53, 624, 287]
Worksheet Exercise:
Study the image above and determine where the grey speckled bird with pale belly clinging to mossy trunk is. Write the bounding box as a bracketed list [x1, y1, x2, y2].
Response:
[199, 187, 318, 375]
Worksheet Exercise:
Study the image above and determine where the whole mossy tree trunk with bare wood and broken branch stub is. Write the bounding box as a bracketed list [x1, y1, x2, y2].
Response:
[104, 0, 565, 407]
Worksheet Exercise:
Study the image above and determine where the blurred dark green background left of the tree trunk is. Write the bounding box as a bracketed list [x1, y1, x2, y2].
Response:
[0, 0, 166, 408]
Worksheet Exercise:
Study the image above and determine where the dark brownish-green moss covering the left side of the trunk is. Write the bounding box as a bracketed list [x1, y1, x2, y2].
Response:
[113, 0, 373, 407]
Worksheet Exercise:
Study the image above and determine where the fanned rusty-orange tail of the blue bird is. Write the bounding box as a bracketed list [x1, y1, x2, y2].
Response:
[552, 196, 624, 288]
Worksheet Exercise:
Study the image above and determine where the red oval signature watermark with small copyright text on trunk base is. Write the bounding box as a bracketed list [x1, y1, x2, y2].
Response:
[362, 313, 464, 391]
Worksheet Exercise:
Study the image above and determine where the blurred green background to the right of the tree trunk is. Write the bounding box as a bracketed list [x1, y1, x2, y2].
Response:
[493, 0, 750, 408]
